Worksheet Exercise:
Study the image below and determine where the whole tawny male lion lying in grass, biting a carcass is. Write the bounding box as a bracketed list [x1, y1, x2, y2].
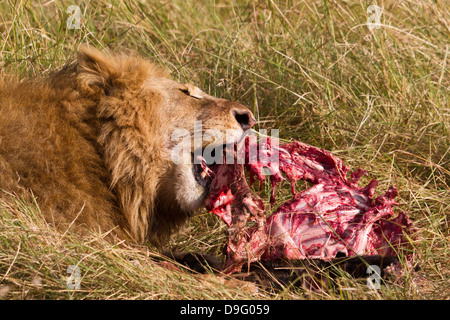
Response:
[0, 48, 254, 244]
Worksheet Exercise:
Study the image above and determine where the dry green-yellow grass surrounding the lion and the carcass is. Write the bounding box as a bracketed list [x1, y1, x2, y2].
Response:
[0, 0, 450, 299]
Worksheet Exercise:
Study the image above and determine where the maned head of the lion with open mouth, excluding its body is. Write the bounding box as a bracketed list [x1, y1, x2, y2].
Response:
[77, 48, 255, 242]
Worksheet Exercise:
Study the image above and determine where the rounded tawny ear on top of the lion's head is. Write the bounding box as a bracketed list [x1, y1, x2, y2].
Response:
[77, 47, 118, 94]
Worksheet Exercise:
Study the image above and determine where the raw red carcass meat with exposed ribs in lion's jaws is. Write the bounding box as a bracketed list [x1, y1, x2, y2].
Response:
[205, 136, 411, 273]
